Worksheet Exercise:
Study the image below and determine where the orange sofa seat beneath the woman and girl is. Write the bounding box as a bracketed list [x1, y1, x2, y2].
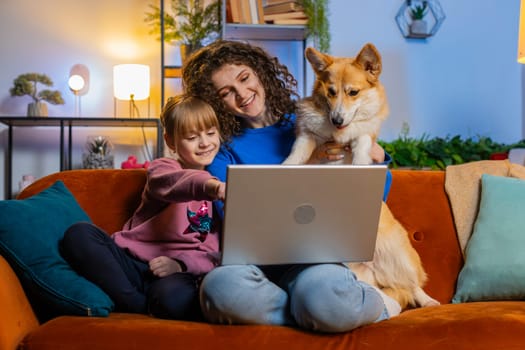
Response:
[22, 301, 525, 350]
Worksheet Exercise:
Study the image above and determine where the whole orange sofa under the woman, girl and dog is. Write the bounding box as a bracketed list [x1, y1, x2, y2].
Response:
[0, 170, 525, 350]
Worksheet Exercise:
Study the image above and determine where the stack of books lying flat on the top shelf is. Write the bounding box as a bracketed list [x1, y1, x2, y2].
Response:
[263, 0, 308, 25]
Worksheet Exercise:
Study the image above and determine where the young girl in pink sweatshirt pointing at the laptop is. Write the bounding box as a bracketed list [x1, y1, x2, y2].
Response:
[61, 95, 225, 319]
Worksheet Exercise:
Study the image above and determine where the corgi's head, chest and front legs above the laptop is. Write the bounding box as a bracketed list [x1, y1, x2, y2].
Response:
[284, 44, 389, 164]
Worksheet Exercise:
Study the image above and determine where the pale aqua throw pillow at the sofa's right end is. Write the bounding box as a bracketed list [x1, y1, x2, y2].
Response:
[452, 174, 525, 303]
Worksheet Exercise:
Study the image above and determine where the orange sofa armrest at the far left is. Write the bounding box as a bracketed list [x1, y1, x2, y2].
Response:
[0, 255, 39, 350]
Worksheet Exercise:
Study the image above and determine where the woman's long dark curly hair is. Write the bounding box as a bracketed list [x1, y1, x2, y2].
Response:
[182, 40, 298, 141]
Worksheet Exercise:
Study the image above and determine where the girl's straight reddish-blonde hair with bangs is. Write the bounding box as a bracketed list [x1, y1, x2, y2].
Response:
[160, 94, 220, 140]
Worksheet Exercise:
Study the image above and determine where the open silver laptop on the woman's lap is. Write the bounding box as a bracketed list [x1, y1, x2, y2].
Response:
[221, 165, 387, 265]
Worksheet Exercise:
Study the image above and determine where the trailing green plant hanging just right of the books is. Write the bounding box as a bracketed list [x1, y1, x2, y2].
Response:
[301, 0, 330, 53]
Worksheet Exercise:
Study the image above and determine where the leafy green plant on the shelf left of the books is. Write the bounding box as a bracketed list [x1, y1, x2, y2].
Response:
[144, 0, 222, 61]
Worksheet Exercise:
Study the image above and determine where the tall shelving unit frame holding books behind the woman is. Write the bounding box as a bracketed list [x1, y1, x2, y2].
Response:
[160, 0, 307, 107]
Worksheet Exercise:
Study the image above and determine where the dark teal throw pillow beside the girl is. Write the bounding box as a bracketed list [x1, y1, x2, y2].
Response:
[0, 181, 113, 321]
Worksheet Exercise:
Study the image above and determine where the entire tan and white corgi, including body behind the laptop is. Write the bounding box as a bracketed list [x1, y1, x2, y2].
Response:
[284, 44, 439, 308]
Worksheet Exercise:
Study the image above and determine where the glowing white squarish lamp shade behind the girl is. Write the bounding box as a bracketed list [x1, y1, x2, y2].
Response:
[113, 64, 150, 100]
